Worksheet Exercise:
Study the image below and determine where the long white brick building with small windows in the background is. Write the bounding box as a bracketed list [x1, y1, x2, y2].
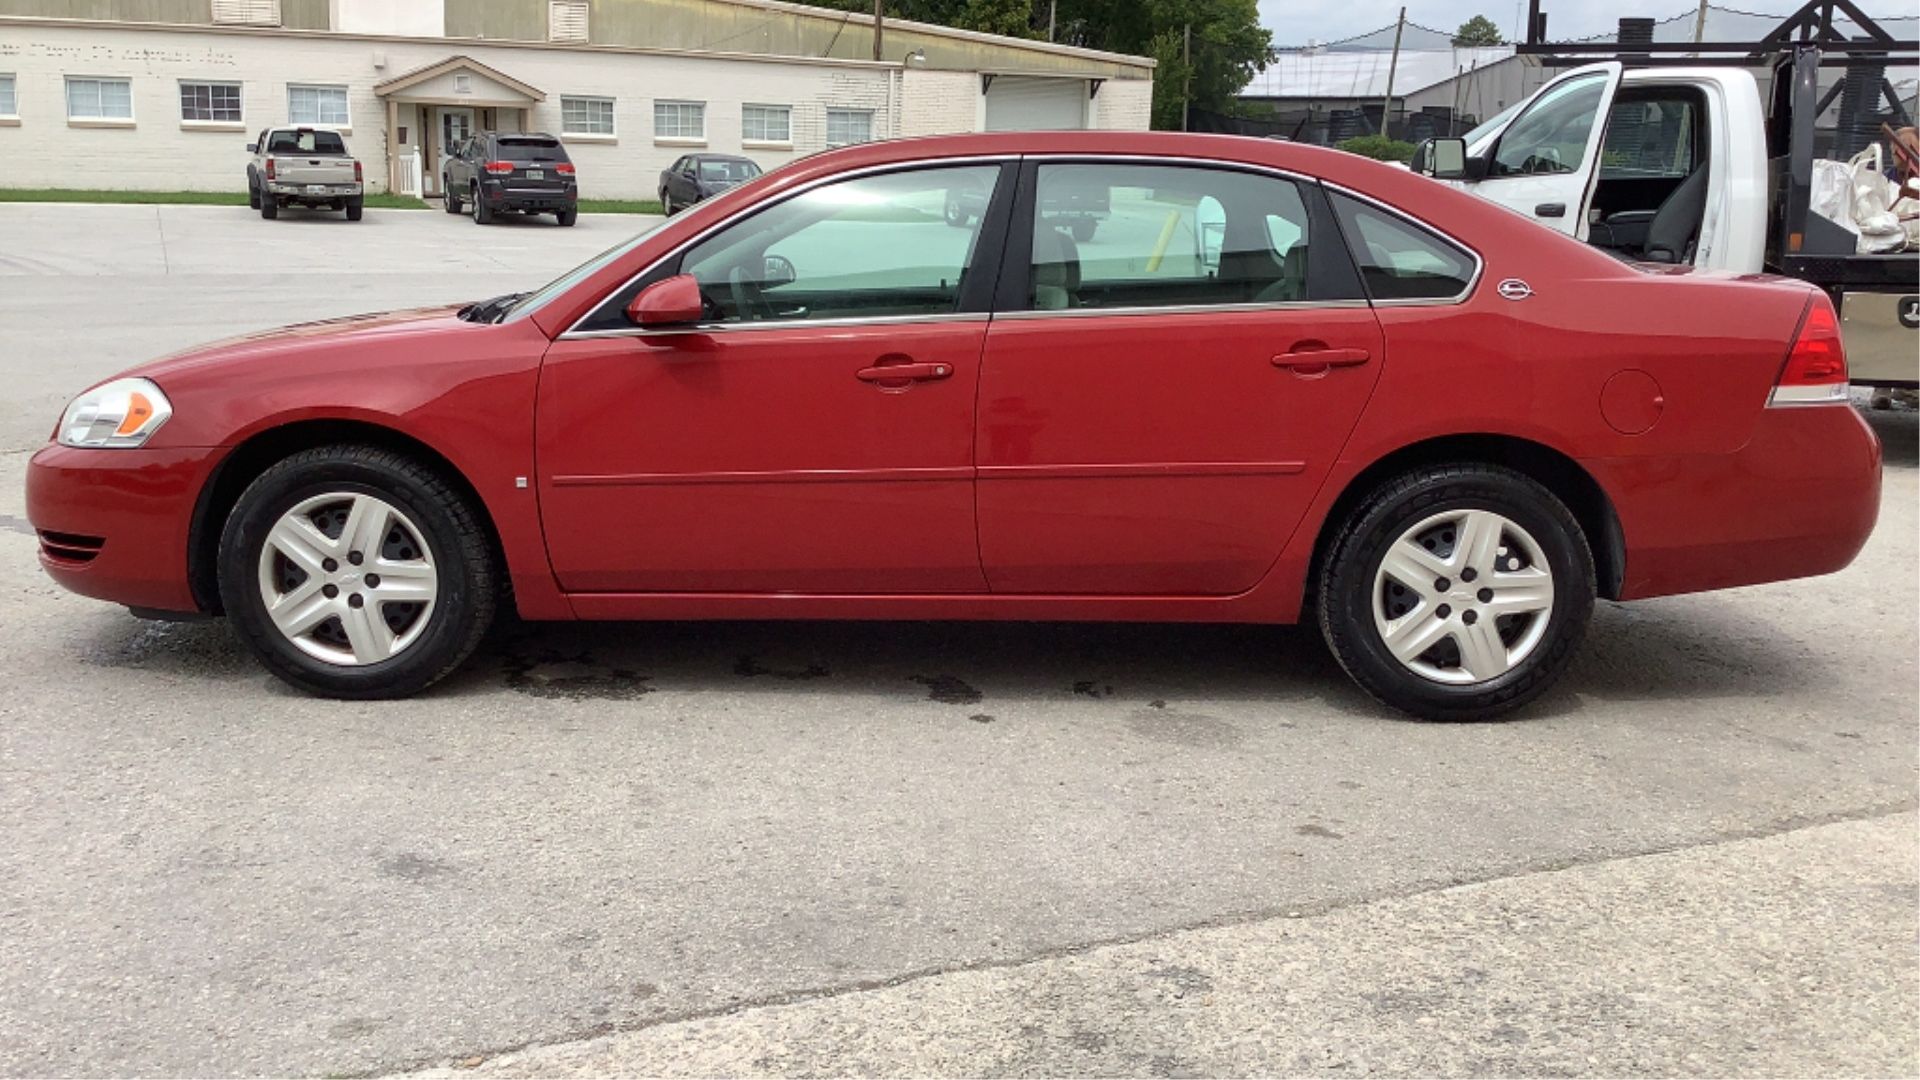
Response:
[0, 0, 1152, 198]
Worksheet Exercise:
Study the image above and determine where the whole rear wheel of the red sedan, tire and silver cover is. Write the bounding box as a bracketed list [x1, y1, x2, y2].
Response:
[1317, 465, 1594, 721]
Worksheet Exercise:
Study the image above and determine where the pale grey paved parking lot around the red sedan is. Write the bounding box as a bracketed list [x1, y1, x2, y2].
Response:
[0, 206, 1920, 1076]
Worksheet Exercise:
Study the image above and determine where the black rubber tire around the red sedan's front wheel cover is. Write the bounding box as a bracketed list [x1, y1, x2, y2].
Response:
[219, 446, 497, 700]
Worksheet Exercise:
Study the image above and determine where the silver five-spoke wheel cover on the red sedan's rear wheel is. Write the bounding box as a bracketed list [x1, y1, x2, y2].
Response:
[1369, 509, 1553, 686]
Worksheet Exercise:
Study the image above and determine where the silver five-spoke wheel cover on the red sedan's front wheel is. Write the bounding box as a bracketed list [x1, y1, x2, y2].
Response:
[259, 492, 440, 667]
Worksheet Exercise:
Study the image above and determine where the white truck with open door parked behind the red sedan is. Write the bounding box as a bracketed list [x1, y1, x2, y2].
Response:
[1411, 42, 1920, 388]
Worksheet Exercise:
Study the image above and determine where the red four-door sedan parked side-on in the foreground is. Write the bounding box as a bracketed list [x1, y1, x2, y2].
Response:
[27, 133, 1880, 719]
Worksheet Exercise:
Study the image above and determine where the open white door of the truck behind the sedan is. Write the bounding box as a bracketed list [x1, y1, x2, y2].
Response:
[1469, 61, 1620, 240]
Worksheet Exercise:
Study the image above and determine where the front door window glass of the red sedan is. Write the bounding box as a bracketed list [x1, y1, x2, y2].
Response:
[680, 165, 1000, 323]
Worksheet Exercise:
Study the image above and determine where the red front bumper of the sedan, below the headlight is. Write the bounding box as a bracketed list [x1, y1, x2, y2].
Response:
[27, 446, 223, 611]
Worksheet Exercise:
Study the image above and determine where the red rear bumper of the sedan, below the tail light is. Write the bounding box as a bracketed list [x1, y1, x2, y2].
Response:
[1582, 405, 1880, 600]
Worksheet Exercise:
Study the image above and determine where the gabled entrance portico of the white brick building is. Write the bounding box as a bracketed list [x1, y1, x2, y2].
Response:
[372, 56, 547, 196]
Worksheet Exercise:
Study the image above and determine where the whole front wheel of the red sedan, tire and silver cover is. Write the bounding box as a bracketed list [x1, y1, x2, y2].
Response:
[219, 446, 495, 698]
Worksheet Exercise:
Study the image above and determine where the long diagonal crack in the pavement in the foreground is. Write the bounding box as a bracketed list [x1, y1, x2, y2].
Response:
[357, 799, 1920, 1078]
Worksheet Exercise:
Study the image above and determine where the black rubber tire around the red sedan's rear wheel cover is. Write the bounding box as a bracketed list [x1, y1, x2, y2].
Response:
[1315, 463, 1594, 721]
